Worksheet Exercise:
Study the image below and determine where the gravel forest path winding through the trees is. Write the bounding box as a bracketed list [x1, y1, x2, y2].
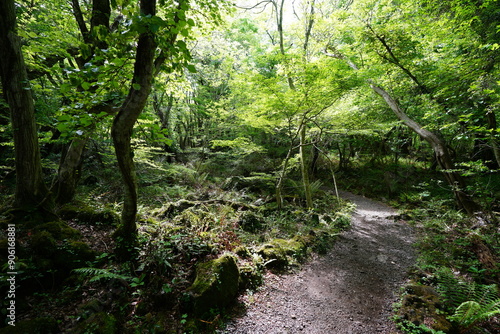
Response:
[219, 192, 415, 334]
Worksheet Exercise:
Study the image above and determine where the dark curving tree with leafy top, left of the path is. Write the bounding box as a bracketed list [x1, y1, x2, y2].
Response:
[111, 0, 225, 254]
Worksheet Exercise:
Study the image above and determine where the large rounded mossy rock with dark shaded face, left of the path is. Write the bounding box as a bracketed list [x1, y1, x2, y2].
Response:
[187, 254, 240, 316]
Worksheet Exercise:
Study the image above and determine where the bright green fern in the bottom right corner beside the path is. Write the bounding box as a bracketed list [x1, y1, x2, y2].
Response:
[438, 271, 500, 333]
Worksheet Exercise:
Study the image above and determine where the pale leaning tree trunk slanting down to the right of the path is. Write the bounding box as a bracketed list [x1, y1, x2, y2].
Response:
[370, 83, 480, 214]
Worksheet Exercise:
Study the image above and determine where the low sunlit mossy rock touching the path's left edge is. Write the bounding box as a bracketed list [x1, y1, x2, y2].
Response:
[257, 237, 307, 269]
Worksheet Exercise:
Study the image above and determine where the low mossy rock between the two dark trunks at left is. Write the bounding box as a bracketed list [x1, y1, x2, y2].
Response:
[58, 204, 120, 226]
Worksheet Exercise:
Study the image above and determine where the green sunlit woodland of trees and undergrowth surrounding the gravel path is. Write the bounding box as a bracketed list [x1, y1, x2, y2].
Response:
[0, 0, 500, 333]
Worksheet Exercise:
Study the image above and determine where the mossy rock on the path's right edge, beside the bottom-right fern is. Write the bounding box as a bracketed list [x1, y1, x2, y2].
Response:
[397, 283, 452, 333]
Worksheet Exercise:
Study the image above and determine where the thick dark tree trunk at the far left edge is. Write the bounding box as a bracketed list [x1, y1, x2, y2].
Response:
[0, 0, 52, 211]
